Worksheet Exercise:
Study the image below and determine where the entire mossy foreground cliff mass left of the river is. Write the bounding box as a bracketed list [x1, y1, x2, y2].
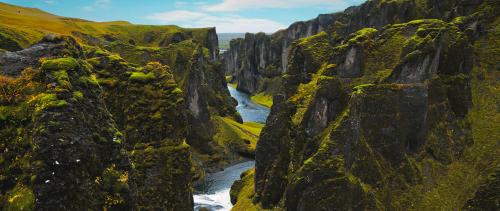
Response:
[0, 36, 199, 210]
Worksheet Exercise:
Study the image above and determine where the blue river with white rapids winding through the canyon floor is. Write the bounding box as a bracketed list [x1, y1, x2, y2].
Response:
[193, 86, 269, 211]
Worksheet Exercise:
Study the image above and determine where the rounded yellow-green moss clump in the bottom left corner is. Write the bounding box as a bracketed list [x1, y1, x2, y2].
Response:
[4, 184, 35, 211]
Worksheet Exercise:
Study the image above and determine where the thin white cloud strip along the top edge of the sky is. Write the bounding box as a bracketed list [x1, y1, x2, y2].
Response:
[203, 0, 346, 12]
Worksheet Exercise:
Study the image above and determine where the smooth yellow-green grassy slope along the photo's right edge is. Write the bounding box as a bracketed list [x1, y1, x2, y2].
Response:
[398, 18, 500, 210]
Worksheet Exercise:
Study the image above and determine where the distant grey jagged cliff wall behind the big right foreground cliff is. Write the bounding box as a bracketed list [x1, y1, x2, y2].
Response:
[223, 0, 483, 94]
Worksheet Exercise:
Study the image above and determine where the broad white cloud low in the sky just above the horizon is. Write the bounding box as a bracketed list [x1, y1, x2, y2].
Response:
[147, 10, 286, 33]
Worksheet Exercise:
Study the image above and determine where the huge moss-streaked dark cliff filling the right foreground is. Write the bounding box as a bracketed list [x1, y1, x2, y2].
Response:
[233, 1, 500, 210]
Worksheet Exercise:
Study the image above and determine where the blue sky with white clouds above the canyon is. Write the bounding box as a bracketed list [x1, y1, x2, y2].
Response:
[0, 0, 365, 33]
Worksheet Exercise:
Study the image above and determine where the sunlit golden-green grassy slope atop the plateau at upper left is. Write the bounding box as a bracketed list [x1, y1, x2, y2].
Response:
[0, 2, 210, 47]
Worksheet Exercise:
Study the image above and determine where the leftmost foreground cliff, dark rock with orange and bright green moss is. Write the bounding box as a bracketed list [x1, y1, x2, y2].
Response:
[0, 37, 136, 210]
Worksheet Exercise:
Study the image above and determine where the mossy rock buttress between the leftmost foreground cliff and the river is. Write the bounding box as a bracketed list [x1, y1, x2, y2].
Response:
[86, 50, 193, 210]
